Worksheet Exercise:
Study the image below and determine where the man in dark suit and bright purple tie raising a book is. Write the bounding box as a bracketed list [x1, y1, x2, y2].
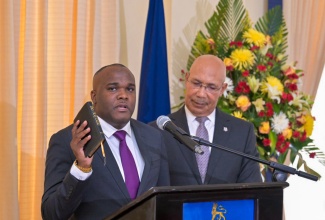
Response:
[41, 64, 169, 219]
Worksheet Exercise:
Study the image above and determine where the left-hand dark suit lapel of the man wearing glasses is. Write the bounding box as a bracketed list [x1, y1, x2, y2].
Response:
[170, 107, 201, 183]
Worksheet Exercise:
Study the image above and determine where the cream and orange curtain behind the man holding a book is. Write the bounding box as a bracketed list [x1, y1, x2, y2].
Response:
[0, 0, 119, 220]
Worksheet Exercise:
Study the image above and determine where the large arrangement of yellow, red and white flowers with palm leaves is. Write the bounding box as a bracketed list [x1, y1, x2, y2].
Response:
[175, 0, 319, 176]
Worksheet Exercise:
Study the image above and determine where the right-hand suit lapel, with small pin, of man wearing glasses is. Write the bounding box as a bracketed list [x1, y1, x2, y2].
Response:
[205, 108, 231, 183]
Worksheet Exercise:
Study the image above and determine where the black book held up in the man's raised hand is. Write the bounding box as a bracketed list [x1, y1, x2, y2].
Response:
[74, 102, 105, 157]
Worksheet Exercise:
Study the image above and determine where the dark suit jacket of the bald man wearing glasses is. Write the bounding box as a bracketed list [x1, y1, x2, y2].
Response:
[150, 107, 262, 186]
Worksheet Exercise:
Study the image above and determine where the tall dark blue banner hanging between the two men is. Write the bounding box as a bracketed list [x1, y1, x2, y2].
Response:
[138, 0, 170, 123]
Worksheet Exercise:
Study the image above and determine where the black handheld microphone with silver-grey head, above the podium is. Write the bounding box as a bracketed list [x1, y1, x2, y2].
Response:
[156, 115, 204, 154]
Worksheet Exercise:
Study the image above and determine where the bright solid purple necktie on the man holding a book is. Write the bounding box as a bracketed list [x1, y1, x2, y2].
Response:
[114, 130, 140, 199]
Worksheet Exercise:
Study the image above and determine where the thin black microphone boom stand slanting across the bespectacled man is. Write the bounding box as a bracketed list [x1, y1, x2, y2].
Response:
[190, 136, 318, 182]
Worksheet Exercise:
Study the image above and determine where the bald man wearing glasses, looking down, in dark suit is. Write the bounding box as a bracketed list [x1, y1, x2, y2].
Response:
[150, 55, 262, 186]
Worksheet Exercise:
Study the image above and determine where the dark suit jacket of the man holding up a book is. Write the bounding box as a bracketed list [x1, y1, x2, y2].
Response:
[42, 119, 169, 220]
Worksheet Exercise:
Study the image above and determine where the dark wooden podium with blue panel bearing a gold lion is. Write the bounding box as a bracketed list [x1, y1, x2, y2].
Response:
[105, 182, 289, 220]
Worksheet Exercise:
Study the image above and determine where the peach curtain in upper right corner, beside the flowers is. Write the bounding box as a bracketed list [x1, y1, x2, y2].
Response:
[283, 0, 325, 97]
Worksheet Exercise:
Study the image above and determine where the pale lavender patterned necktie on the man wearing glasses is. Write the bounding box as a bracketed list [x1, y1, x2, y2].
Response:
[195, 117, 210, 183]
